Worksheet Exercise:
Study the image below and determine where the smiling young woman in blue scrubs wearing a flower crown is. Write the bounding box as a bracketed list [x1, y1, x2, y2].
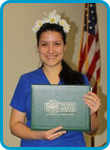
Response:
[10, 11, 100, 147]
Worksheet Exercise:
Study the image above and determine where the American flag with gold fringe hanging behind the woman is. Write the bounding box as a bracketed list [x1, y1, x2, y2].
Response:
[78, 3, 100, 93]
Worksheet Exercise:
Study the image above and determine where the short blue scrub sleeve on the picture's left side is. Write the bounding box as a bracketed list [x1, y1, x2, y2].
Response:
[10, 77, 26, 112]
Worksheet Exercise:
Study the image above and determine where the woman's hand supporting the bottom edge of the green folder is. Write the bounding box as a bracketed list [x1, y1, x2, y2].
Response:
[34, 126, 66, 141]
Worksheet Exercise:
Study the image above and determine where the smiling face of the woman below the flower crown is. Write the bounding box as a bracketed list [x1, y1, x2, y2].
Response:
[38, 31, 66, 67]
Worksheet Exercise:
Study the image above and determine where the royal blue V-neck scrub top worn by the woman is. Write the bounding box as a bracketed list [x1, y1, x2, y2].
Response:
[10, 68, 89, 147]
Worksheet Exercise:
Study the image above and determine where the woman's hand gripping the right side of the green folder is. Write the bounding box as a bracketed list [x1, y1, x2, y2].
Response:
[84, 92, 101, 115]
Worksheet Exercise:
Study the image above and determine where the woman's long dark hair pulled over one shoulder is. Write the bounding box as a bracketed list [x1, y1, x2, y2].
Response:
[36, 23, 84, 85]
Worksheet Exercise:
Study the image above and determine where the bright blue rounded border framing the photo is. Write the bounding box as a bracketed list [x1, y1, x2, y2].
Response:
[0, 0, 110, 150]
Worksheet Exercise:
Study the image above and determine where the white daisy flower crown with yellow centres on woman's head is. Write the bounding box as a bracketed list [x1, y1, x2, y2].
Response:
[32, 10, 70, 33]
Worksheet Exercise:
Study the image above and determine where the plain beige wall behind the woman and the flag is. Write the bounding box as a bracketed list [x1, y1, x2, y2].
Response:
[3, 3, 107, 147]
